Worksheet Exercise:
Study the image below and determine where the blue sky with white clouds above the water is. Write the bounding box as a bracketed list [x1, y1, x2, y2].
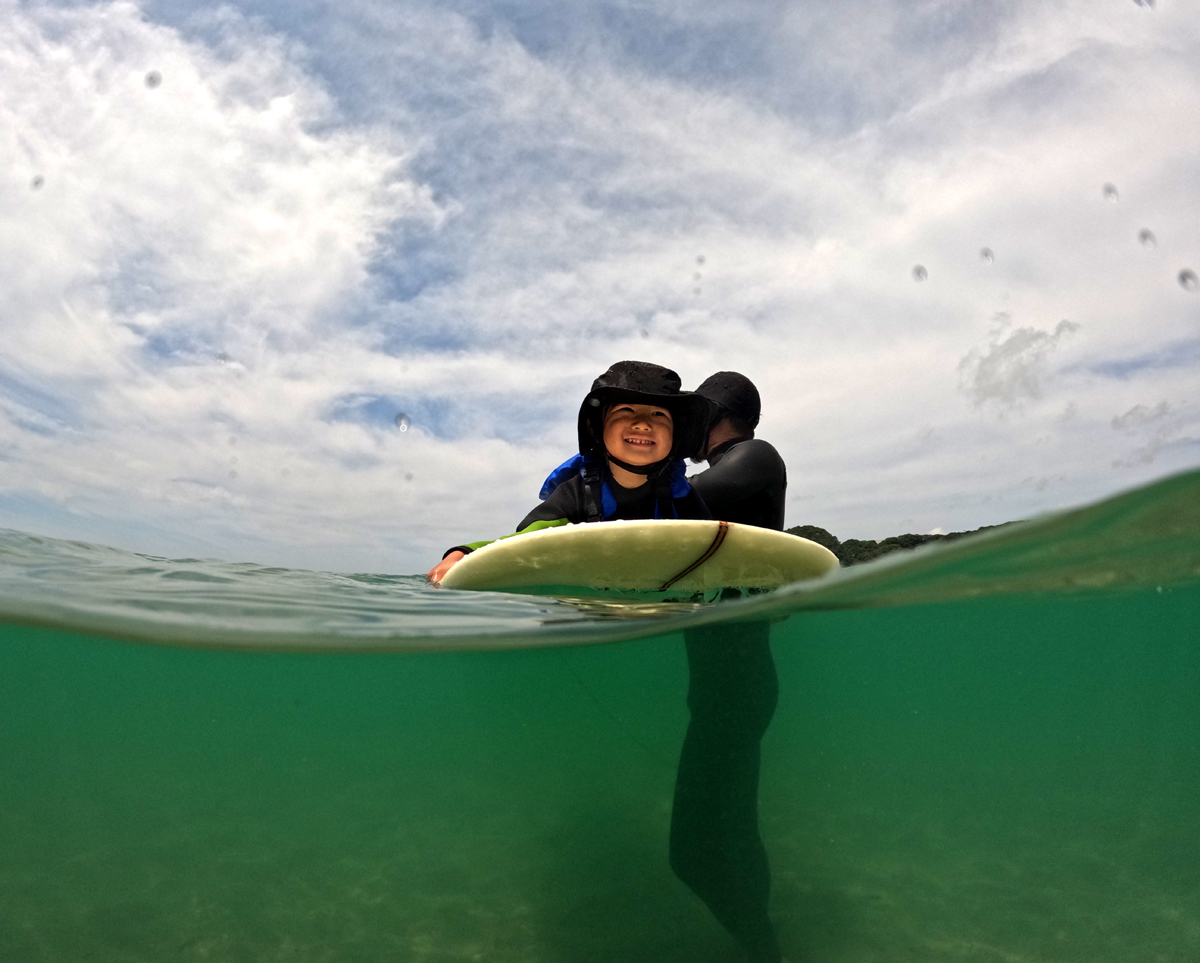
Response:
[0, 0, 1200, 573]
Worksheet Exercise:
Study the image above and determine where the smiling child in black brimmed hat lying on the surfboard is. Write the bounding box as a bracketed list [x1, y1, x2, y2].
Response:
[428, 361, 712, 573]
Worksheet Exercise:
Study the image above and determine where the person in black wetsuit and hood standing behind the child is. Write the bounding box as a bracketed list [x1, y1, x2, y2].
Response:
[671, 371, 787, 963]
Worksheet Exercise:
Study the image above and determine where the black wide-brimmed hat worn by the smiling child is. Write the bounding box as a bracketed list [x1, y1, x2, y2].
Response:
[578, 361, 708, 461]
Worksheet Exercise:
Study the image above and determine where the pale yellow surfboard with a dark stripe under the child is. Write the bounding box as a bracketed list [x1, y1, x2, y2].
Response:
[442, 520, 838, 594]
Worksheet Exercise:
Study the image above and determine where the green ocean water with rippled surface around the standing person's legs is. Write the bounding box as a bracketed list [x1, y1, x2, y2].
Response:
[0, 473, 1200, 963]
